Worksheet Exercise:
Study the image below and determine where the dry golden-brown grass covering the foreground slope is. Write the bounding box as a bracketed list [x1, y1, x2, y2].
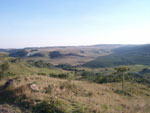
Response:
[1, 75, 150, 113]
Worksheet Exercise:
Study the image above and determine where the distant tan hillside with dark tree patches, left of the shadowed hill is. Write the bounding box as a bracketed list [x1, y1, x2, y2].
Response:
[0, 44, 121, 66]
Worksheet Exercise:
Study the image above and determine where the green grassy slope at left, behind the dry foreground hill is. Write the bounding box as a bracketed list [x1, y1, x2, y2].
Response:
[0, 53, 66, 75]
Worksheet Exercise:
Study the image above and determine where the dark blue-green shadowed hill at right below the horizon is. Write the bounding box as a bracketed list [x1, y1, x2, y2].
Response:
[83, 44, 150, 68]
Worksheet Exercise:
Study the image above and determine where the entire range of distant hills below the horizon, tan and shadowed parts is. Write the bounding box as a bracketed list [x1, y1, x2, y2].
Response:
[0, 44, 150, 67]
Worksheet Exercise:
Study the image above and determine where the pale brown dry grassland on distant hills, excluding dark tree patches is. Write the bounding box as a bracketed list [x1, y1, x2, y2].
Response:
[26, 46, 115, 66]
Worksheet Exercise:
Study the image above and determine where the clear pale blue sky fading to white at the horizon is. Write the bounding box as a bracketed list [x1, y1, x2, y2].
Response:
[0, 0, 150, 48]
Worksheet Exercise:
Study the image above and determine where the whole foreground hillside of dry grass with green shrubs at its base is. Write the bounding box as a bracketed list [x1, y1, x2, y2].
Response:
[0, 75, 150, 113]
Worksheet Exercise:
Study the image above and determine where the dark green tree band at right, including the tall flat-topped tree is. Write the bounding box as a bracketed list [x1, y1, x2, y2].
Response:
[78, 66, 150, 93]
